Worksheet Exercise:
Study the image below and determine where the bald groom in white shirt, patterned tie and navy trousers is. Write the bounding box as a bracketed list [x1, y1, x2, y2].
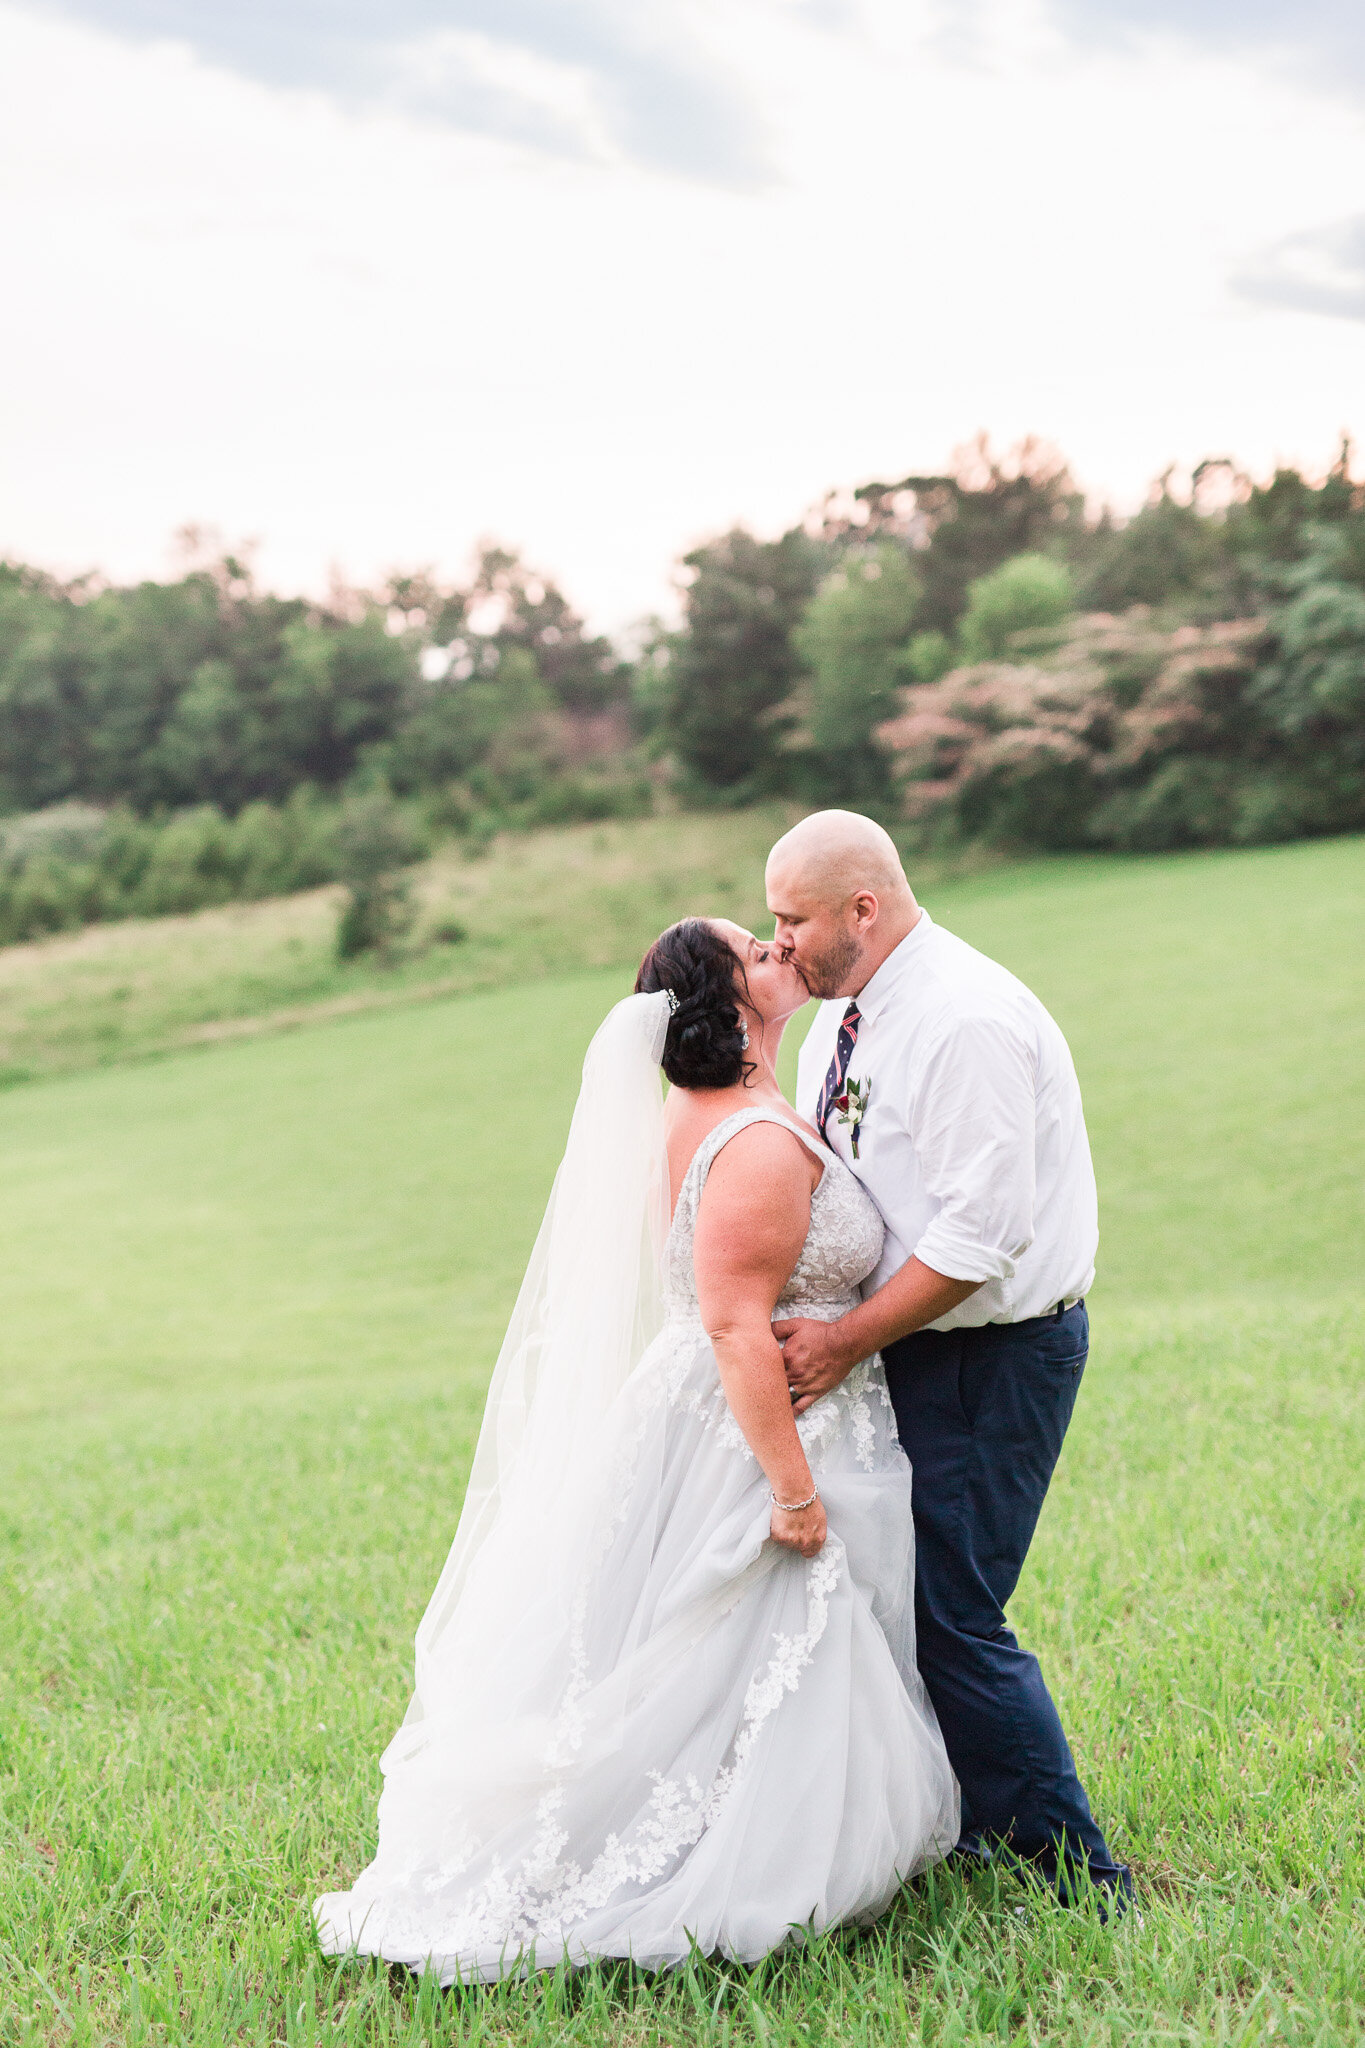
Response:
[767, 811, 1132, 1898]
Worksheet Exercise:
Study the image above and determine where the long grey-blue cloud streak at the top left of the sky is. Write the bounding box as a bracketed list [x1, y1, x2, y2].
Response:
[39, 0, 765, 186]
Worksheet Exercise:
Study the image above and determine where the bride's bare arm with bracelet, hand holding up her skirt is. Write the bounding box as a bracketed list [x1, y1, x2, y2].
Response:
[692, 1124, 825, 1556]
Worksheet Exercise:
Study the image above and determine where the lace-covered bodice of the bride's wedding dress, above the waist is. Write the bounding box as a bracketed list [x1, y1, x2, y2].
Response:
[663, 1108, 882, 1323]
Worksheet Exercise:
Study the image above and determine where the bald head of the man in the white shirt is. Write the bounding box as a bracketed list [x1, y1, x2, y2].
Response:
[767, 811, 919, 995]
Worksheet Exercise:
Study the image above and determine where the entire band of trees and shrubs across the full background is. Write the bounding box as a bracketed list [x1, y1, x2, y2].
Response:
[0, 440, 1365, 938]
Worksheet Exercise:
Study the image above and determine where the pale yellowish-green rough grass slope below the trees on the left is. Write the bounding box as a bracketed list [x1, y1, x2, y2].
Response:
[0, 805, 990, 1087]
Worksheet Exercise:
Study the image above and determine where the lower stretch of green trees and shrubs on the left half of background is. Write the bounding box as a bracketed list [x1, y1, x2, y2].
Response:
[0, 549, 653, 952]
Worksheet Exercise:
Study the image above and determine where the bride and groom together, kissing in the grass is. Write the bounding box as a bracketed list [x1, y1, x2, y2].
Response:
[313, 811, 1132, 1985]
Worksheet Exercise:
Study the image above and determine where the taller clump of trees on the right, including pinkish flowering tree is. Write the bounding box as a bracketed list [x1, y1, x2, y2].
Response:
[653, 442, 1365, 850]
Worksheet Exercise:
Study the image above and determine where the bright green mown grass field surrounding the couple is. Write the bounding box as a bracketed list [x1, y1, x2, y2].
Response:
[0, 827, 1365, 2048]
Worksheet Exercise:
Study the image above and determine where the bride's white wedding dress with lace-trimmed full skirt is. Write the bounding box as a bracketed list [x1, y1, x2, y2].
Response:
[313, 997, 958, 1985]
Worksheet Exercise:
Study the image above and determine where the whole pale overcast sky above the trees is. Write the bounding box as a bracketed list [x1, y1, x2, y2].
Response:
[0, 0, 1365, 629]
